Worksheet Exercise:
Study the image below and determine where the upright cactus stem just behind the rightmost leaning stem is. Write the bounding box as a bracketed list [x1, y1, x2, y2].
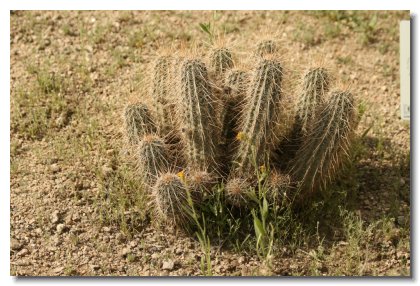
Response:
[296, 68, 330, 134]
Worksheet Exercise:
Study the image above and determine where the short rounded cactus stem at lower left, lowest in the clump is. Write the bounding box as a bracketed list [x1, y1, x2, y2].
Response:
[152, 173, 190, 225]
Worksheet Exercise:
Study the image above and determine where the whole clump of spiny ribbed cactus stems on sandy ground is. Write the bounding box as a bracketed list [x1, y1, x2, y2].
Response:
[123, 40, 356, 227]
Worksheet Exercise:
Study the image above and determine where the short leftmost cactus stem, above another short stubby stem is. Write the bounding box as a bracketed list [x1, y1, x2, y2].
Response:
[124, 103, 157, 145]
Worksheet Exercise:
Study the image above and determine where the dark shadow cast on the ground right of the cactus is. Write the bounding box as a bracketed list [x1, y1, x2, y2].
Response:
[295, 136, 410, 244]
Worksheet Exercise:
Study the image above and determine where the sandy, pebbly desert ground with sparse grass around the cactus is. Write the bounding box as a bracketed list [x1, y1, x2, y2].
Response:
[10, 11, 411, 276]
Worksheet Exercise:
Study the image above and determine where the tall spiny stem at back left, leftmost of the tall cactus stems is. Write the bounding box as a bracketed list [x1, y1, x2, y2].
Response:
[152, 56, 173, 135]
